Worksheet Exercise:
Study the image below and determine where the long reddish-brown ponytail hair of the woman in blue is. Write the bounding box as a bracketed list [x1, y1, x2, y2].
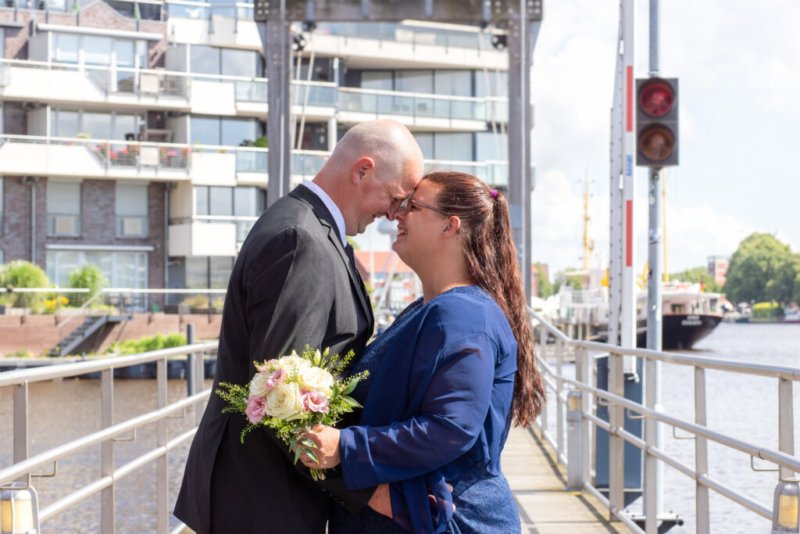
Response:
[423, 171, 545, 426]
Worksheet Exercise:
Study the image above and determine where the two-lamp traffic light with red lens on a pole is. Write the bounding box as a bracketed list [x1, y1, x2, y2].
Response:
[636, 78, 678, 167]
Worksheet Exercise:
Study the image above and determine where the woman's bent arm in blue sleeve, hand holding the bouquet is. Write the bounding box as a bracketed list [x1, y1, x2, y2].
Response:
[304, 334, 495, 489]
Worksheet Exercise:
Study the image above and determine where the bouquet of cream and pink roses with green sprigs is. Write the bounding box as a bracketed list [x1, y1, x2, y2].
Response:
[216, 346, 368, 480]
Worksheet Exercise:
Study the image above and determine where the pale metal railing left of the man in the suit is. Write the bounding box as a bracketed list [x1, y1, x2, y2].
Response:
[0, 341, 217, 534]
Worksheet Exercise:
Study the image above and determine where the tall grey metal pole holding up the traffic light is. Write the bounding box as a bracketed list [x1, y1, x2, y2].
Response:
[644, 0, 664, 533]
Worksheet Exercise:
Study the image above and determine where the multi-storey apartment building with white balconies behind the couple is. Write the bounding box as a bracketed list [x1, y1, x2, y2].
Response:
[0, 0, 508, 303]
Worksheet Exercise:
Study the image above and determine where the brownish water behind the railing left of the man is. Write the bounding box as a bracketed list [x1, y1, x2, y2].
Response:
[0, 379, 211, 534]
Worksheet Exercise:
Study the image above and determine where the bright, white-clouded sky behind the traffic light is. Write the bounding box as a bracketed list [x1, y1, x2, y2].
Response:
[359, 0, 800, 280]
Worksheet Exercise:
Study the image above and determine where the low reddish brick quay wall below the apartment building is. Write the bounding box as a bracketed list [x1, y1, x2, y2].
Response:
[0, 313, 222, 355]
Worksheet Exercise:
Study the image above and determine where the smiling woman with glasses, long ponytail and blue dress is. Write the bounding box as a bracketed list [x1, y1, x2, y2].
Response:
[302, 172, 544, 533]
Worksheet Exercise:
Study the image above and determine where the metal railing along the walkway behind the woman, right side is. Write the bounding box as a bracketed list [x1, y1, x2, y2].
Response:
[530, 311, 800, 534]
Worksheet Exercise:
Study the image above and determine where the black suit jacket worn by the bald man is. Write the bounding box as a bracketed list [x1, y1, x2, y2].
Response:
[175, 186, 374, 533]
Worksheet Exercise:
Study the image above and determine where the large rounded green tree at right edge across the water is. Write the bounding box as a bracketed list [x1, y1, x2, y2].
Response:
[724, 233, 800, 303]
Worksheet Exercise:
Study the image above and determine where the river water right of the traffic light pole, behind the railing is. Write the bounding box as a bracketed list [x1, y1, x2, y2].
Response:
[661, 323, 800, 532]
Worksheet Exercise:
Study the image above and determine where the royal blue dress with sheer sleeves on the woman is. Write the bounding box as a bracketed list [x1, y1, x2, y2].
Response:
[329, 286, 520, 534]
